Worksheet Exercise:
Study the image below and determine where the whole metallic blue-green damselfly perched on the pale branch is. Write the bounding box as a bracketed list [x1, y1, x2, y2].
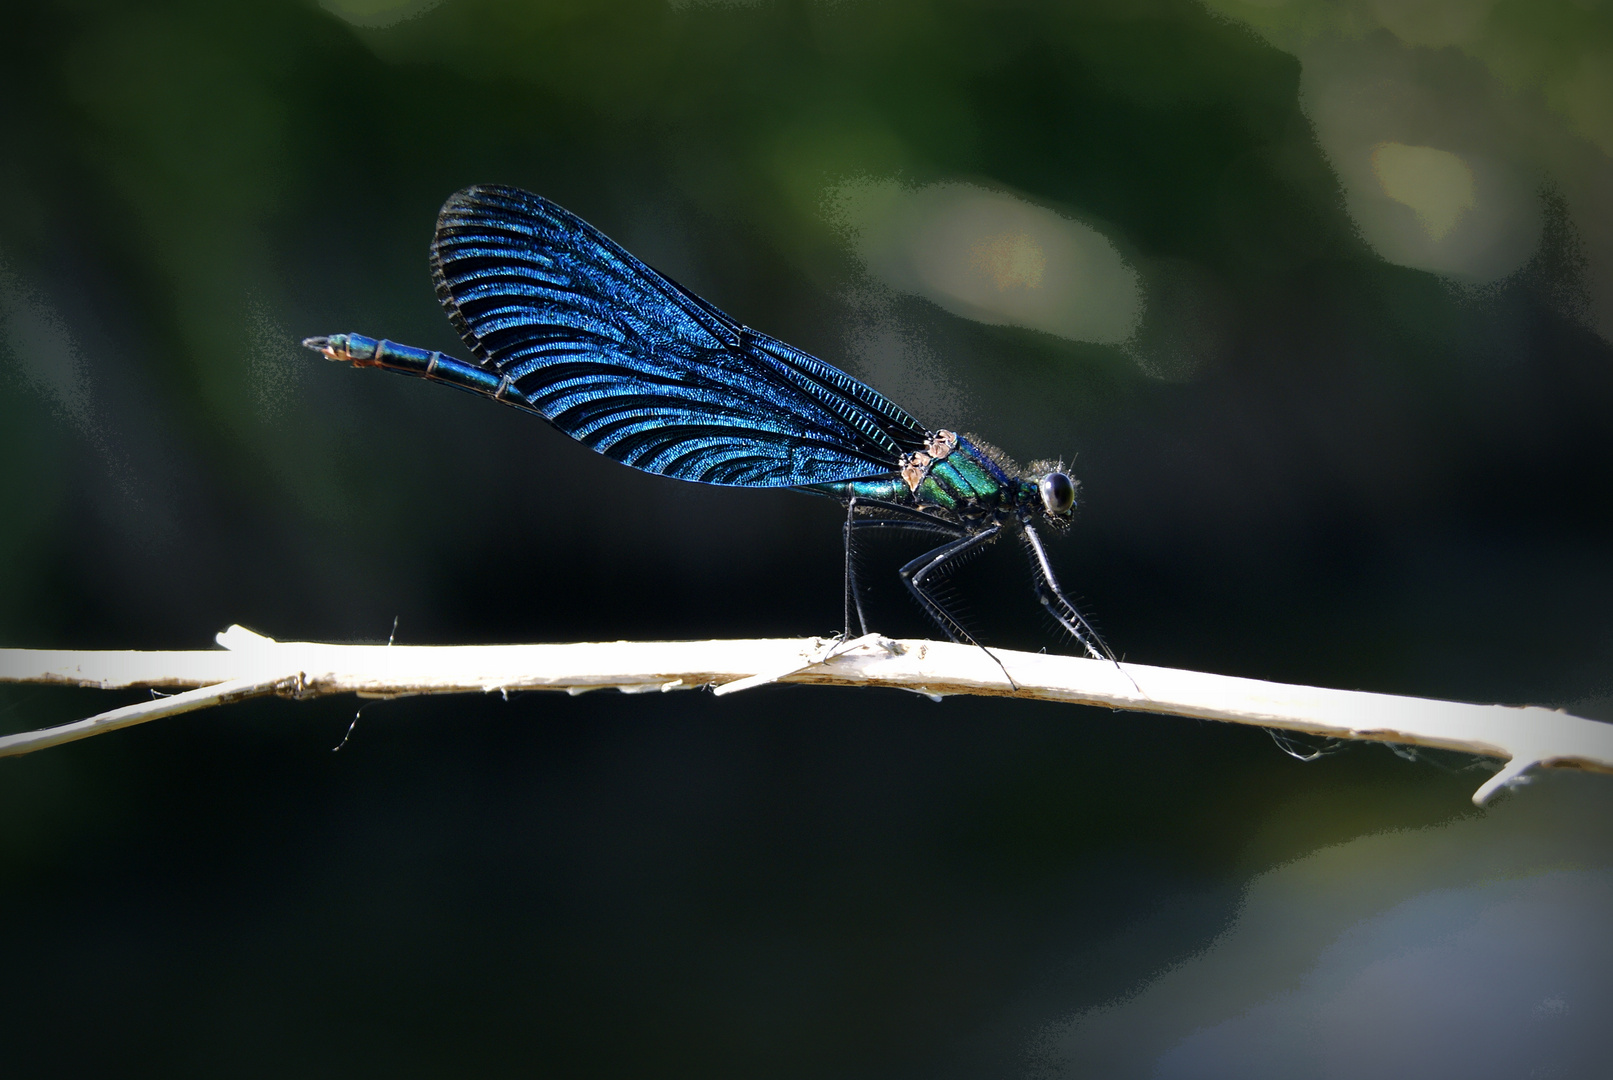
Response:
[303, 185, 1115, 659]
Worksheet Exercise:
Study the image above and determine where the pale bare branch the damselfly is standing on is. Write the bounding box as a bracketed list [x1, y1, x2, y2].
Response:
[0, 625, 1613, 806]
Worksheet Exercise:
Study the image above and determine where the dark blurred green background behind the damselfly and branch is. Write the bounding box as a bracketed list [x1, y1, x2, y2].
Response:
[0, 0, 1613, 1077]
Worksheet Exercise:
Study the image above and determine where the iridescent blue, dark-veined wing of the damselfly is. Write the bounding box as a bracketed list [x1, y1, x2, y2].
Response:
[431, 185, 926, 487]
